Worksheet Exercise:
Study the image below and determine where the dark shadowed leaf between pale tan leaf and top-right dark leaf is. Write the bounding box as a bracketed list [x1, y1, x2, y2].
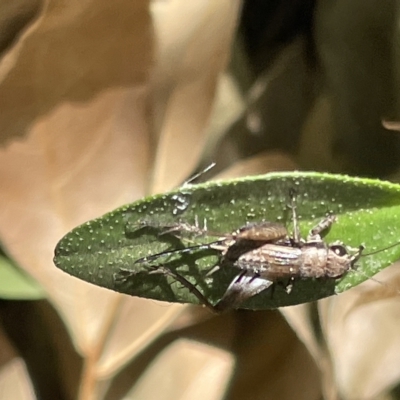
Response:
[206, 38, 314, 175]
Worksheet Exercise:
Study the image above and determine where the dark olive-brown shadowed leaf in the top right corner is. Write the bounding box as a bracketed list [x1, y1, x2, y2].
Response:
[313, 0, 399, 176]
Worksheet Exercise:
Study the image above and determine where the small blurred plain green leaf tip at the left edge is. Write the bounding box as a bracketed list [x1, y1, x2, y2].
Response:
[0, 254, 45, 300]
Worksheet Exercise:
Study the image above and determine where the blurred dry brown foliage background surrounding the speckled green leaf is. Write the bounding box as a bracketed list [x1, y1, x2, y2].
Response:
[0, 0, 400, 400]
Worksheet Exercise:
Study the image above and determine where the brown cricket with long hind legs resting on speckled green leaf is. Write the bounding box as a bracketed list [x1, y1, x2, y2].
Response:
[121, 191, 372, 313]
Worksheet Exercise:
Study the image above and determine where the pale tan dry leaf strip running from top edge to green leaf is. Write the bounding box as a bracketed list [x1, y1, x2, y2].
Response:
[148, 0, 240, 193]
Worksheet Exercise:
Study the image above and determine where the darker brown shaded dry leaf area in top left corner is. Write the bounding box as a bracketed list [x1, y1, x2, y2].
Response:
[0, 0, 152, 142]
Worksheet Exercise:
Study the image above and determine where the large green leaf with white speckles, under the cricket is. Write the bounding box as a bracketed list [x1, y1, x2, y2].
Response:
[54, 172, 400, 309]
